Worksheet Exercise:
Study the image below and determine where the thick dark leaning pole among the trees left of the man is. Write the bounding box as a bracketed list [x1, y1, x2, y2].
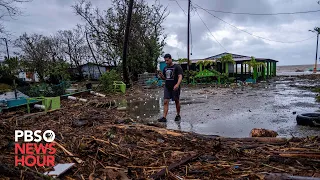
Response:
[122, 0, 133, 85]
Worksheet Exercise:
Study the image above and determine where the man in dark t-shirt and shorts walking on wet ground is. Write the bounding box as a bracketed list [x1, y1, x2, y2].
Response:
[158, 54, 183, 122]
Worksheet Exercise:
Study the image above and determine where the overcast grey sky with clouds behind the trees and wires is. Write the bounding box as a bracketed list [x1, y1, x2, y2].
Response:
[0, 0, 320, 65]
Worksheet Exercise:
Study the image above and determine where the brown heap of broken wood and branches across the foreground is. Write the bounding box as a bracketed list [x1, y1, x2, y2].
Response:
[0, 95, 320, 179]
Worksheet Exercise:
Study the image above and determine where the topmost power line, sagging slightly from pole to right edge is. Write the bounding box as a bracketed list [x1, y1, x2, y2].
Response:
[195, 4, 320, 16]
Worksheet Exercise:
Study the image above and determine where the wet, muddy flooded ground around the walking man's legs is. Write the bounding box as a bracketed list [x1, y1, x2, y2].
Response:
[120, 77, 320, 137]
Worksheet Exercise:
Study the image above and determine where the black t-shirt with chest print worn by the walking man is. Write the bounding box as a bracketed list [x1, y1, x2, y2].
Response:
[163, 64, 183, 90]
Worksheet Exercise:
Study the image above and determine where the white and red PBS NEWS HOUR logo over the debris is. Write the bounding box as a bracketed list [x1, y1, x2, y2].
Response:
[14, 130, 57, 167]
